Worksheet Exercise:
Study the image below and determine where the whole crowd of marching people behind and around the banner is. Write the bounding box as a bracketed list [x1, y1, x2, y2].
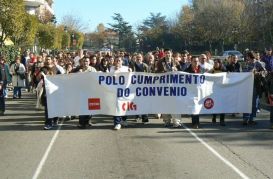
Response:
[0, 48, 273, 130]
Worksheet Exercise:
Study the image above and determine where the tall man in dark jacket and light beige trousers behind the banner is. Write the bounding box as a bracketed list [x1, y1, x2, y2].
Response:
[157, 49, 181, 127]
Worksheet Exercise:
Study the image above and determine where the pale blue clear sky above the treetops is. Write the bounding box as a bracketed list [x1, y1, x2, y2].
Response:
[53, 0, 188, 31]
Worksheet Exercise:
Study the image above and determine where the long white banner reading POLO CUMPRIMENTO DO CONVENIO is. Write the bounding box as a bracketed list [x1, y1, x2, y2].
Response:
[45, 72, 254, 117]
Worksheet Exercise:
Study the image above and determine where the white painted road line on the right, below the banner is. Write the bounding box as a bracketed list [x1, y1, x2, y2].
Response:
[181, 124, 249, 179]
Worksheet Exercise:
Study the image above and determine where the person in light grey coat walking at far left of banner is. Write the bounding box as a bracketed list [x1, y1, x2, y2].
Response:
[10, 56, 26, 99]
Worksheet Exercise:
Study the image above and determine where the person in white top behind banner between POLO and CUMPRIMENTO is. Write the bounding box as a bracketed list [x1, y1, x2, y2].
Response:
[110, 56, 132, 130]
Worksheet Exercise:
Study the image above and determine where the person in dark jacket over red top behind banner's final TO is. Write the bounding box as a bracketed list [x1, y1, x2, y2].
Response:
[185, 56, 205, 129]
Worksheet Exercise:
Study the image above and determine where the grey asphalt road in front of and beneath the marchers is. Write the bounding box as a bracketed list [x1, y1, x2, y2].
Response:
[0, 93, 273, 179]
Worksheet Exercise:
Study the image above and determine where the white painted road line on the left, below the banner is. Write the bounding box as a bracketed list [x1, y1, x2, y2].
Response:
[32, 120, 63, 179]
